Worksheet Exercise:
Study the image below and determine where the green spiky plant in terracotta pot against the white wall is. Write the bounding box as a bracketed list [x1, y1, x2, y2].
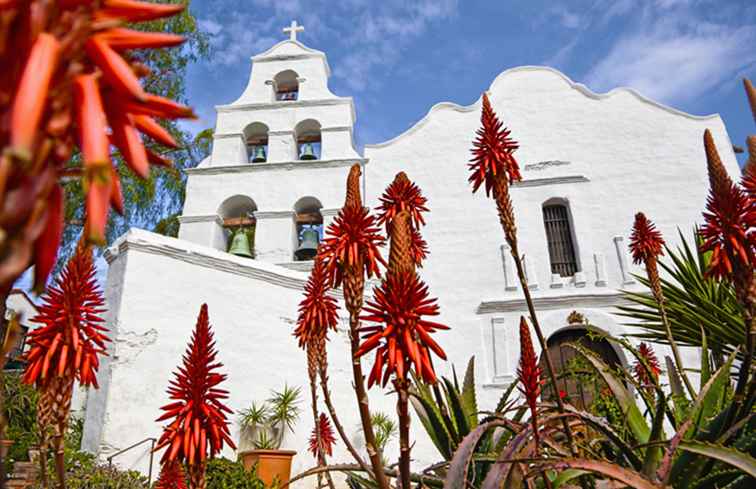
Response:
[239, 386, 300, 486]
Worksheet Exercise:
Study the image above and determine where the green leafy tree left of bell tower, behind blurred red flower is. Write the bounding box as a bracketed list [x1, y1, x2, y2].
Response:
[58, 0, 212, 269]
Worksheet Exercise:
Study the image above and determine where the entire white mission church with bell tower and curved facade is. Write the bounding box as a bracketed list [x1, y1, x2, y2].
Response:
[60, 21, 739, 480]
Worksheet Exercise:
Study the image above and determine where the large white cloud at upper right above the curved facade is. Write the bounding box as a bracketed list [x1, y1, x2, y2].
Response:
[586, 19, 756, 103]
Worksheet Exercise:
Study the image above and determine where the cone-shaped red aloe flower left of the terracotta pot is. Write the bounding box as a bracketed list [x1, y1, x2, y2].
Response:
[155, 304, 236, 467]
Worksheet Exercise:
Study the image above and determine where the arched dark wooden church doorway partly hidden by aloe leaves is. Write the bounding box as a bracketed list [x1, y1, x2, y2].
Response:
[539, 313, 628, 410]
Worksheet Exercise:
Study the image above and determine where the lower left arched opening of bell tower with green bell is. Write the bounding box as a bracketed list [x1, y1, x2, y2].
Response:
[218, 195, 257, 258]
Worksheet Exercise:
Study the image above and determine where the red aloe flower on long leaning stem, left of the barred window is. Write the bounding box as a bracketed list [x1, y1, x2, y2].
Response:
[468, 93, 522, 195]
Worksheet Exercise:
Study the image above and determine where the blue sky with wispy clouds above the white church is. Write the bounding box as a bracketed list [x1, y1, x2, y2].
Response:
[188, 0, 756, 164]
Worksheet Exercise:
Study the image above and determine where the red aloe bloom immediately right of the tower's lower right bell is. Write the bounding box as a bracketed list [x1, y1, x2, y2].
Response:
[321, 205, 385, 287]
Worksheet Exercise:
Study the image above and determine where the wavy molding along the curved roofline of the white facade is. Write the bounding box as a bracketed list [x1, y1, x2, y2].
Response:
[365, 66, 719, 150]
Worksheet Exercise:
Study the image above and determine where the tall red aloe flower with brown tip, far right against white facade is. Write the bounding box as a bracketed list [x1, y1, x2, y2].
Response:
[701, 130, 756, 278]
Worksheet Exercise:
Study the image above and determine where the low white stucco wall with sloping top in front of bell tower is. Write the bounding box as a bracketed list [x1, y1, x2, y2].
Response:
[84, 229, 434, 487]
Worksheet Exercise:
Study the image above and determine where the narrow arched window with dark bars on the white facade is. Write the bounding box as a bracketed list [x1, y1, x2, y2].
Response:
[543, 199, 578, 277]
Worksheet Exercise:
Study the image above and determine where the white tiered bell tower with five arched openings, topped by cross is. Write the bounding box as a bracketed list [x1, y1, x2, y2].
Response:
[179, 21, 367, 269]
